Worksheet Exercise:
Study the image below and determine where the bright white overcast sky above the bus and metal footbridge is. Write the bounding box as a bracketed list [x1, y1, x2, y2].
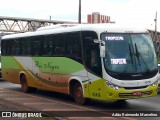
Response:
[0, 0, 160, 31]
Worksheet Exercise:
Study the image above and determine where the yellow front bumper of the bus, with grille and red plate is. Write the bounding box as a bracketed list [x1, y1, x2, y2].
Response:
[86, 81, 158, 100]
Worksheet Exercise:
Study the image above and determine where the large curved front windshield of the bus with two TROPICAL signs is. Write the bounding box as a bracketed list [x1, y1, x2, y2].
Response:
[101, 33, 157, 79]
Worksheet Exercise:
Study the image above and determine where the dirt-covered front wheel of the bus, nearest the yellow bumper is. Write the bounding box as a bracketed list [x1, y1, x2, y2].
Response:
[73, 83, 89, 105]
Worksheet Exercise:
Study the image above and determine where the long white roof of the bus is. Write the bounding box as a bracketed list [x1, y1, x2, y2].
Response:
[2, 24, 148, 39]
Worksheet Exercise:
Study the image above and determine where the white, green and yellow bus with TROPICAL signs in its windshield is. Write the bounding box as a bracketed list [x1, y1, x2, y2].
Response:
[2, 24, 158, 104]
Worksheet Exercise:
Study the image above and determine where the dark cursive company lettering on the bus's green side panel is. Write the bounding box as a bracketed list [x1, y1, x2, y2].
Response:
[35, 61, 59, 71]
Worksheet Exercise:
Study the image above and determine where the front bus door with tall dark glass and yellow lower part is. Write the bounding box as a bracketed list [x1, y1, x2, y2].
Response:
[82, 32, 102, 98]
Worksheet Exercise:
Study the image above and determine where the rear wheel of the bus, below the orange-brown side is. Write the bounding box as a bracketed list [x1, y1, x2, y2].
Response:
[20, 75, 37, 93]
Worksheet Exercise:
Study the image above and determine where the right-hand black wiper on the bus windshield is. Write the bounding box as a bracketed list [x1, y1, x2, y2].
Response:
[135, 43, 150, 72]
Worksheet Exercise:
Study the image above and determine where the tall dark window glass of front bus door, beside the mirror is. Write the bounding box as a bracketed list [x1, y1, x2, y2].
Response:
[82, 31, 102, 76]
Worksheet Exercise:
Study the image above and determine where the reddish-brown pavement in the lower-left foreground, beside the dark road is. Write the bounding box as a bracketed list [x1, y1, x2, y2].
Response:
[0, 84, 159, 120]
